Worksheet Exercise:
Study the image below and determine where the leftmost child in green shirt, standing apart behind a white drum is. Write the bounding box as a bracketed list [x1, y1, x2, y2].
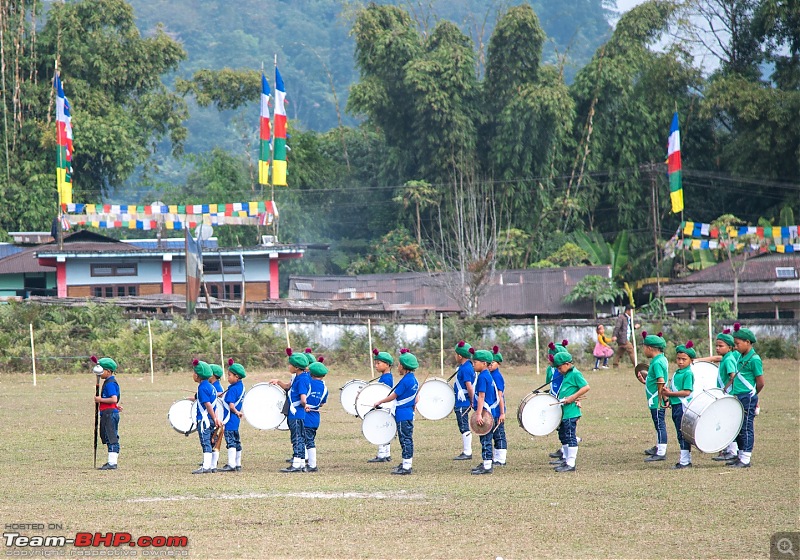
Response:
[553, 352, 589, 472]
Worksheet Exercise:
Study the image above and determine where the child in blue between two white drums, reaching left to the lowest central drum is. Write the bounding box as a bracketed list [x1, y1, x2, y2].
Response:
[374, 348, 419, 475]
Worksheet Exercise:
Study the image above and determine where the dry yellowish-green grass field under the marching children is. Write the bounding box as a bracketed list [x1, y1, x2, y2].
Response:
[0, 360, 800, 559]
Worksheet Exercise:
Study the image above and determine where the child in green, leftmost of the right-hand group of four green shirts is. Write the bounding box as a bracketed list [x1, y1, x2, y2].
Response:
[640, 331, 669, 463]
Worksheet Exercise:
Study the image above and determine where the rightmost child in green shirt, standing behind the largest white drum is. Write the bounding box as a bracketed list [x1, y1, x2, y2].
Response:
[725, 323, 764, 469]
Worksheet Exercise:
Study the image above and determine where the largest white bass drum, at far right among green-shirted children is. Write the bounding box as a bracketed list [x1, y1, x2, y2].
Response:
[681, 388, 744, 453]
